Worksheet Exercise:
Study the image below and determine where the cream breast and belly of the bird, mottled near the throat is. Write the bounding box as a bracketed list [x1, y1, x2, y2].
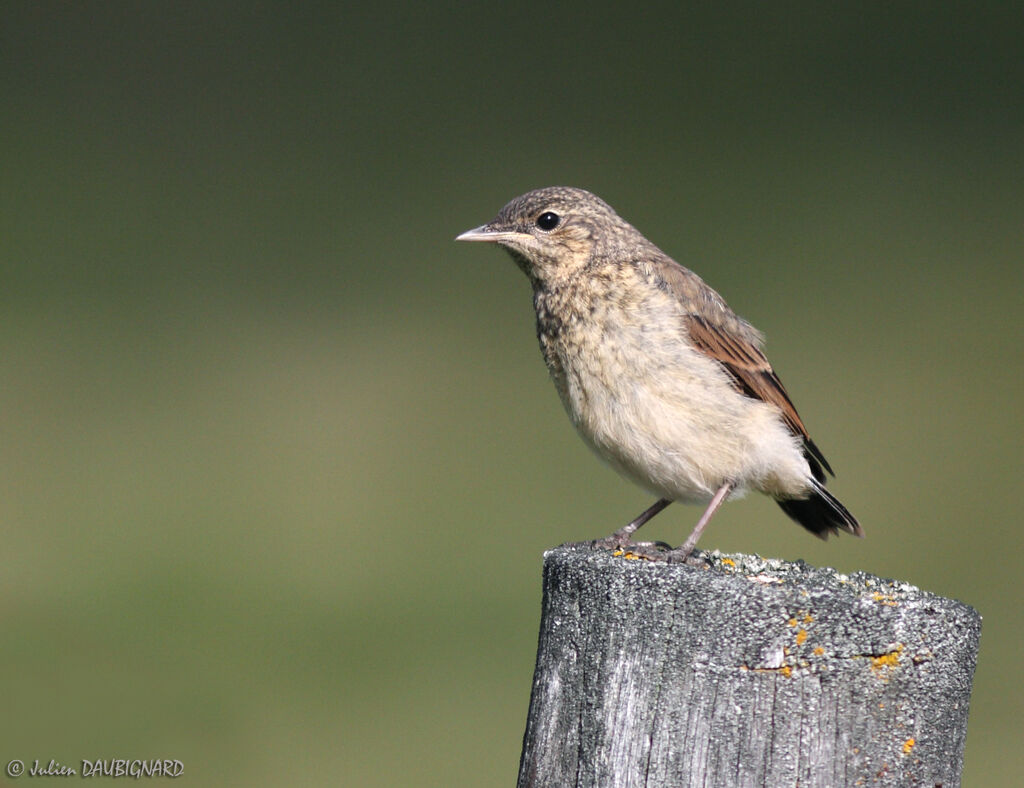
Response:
[536, 274, 803, 499]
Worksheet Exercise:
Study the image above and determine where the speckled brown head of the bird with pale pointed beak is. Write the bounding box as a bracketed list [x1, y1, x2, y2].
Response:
[456, 186, 642, 283]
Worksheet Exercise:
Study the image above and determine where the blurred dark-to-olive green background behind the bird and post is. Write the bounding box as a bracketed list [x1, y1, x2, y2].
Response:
[0, 2, 1024, 786]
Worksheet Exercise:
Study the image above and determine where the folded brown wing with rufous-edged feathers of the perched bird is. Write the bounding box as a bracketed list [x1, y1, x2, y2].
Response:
[654, 258, 833, 481]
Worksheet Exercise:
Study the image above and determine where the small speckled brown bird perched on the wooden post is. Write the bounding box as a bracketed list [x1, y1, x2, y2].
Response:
[456, 186, 863, 562]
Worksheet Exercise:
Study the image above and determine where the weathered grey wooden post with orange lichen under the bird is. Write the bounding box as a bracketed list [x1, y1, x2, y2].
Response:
[518, 545, 981, 788]
